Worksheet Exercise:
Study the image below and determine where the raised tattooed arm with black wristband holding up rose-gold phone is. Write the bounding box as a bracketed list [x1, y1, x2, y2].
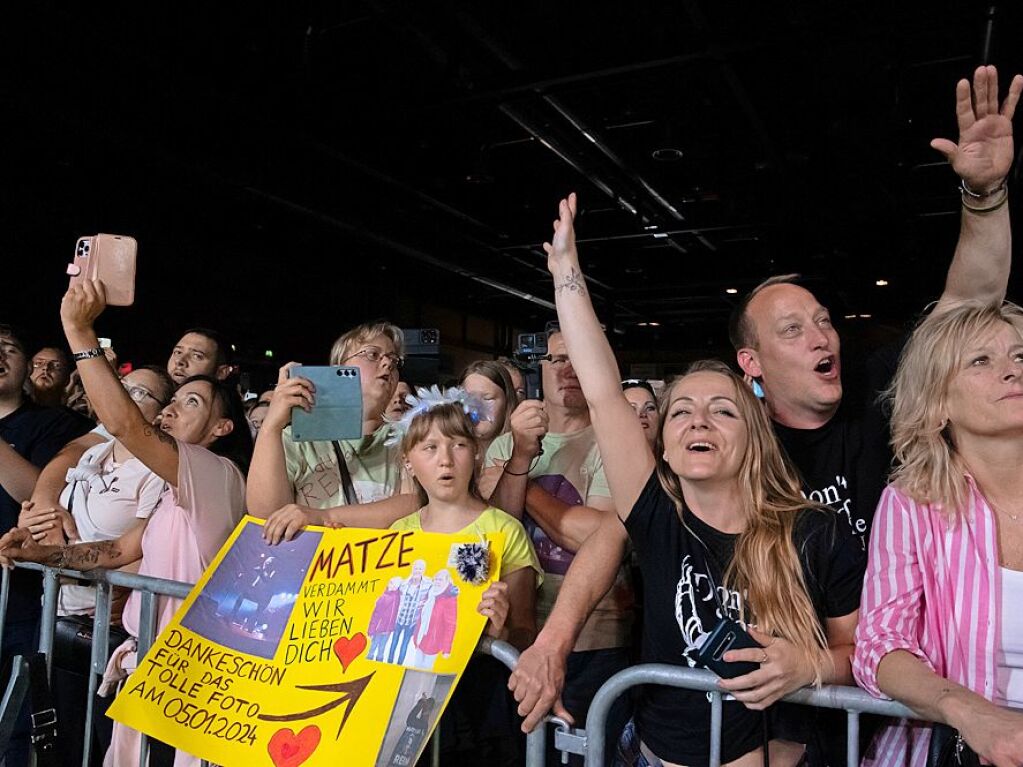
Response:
[60, 279, 178, 487]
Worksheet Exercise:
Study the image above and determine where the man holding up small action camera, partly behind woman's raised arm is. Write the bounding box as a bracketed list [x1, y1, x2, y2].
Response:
[483, 331, 633, 757]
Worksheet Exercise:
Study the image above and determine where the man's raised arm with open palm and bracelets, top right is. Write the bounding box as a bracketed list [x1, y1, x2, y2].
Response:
[931, 66, 1023, 311]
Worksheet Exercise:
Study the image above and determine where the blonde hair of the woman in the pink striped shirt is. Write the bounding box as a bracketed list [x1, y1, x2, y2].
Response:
[883, 302, 1023, 516]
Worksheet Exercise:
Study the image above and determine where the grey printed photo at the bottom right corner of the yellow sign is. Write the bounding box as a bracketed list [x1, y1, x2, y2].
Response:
[376, 671, 455, 767]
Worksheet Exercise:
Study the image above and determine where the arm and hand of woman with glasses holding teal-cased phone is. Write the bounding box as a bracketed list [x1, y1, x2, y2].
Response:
[246, 362, 316, 520]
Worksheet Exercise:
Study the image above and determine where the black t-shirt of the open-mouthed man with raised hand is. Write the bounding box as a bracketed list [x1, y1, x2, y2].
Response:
[774, 337, 905, 551]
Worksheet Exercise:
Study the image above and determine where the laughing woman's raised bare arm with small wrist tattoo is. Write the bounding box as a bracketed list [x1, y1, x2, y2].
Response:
[543, 193, 654, 520]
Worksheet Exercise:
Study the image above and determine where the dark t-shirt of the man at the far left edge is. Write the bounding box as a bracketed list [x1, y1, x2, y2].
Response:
[0, 400, 95, 620]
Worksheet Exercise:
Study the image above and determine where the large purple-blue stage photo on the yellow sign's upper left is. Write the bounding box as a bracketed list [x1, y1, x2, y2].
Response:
[181, 525, 321, 659]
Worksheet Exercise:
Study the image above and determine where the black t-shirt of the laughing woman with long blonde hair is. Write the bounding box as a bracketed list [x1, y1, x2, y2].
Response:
[625, 473, 865, 767]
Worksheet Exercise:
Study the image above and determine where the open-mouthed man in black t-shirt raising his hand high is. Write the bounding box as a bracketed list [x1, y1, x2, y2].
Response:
[728, 66, 1023, 549]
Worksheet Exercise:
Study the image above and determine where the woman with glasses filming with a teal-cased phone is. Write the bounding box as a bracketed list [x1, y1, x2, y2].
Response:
[247, 321, 416, 543]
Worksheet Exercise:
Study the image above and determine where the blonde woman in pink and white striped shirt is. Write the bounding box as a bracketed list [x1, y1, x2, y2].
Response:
[853, 304, 1023, 767]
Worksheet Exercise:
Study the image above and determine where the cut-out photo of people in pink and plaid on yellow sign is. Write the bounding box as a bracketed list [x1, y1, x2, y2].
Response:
[366, 559, 458, 671]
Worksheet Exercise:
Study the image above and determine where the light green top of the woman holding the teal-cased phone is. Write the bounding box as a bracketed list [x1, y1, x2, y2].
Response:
[281, 423, 402, 508]
